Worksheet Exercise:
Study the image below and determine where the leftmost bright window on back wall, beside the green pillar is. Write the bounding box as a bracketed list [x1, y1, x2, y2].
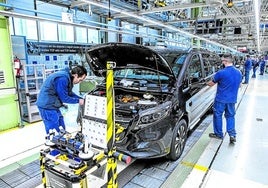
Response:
[13, 18, 37, 40]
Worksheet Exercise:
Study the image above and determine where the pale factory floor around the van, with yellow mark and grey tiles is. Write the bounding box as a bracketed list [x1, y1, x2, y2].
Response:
[0, 74, 268, 188]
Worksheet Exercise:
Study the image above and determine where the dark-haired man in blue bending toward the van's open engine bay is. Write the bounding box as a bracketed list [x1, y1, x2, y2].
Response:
[36, 65, 87, 134]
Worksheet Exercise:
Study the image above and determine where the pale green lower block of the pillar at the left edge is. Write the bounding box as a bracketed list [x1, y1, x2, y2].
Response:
[0, 95, 20, 132]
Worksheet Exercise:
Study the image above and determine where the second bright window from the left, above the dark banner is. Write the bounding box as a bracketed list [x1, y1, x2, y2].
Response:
[40, 22, 58, 41]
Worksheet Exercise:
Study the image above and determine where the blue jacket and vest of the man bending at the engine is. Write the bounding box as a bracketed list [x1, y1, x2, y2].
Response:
[36, 69, 81, 109]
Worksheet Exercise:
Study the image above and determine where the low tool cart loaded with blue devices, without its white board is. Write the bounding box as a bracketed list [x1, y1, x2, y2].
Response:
[40, 126, 131, 188]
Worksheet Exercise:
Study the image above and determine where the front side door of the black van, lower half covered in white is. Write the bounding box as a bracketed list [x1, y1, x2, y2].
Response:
[186, 52, 221, 129]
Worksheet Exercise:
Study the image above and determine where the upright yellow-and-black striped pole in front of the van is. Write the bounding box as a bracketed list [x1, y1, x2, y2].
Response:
[106, 61, 118, 188]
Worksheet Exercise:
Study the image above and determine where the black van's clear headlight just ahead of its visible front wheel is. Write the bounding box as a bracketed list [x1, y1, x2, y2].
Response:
[138, 101, 171, 127]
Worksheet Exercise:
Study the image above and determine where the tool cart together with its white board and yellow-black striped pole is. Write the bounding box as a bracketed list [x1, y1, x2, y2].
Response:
[40, 62, 131, 188]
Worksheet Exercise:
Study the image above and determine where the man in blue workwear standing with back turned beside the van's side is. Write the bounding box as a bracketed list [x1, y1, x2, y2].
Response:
[207, 54, 242, 143]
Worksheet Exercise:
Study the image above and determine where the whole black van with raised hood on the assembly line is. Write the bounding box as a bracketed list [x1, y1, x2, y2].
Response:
[82, 43, 221, 160]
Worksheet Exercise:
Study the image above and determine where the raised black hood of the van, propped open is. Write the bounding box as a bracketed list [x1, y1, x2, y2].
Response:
[86, 43, 174, 78]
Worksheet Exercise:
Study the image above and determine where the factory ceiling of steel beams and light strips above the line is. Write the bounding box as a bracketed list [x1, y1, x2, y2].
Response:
[31, 0, 268, 53]
